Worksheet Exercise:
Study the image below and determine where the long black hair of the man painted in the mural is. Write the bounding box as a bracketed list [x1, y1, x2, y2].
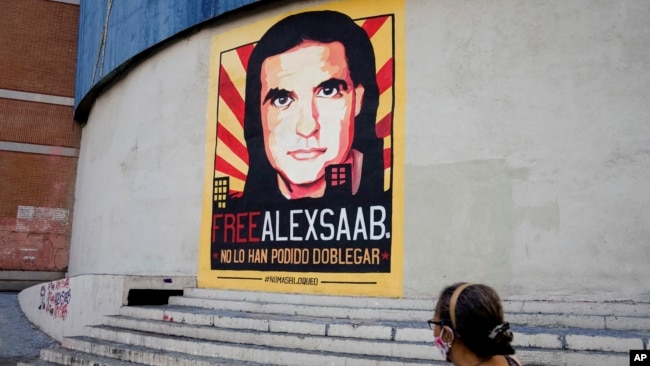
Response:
[243, 11, 384, 203]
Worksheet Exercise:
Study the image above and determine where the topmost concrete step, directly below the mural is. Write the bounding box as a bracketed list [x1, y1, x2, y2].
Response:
[169, 289, 650, 331]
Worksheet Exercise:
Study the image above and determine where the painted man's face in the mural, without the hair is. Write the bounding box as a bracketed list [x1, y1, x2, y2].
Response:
[260, 41, 364, 197]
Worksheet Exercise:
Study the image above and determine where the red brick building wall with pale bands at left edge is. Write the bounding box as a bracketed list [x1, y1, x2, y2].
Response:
[0, 0, 81, 271]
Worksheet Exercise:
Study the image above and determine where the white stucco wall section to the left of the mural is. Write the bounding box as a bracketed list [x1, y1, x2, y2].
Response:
[69, 34, 210, 275]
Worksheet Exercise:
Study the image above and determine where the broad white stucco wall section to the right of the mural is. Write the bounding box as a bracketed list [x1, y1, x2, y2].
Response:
[405, 1, 650, 301]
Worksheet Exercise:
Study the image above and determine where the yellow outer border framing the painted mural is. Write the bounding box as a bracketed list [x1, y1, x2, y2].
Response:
[198, 0, 406, 297]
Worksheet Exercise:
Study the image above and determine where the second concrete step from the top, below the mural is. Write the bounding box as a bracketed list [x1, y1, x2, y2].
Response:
[114, 305, 650, 352]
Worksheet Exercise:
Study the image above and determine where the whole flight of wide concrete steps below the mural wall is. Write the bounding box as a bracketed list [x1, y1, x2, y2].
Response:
[19, 289, 650, 366]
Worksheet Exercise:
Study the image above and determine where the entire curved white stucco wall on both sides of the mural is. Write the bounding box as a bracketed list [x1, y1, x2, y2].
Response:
[70, 0, 650, 301]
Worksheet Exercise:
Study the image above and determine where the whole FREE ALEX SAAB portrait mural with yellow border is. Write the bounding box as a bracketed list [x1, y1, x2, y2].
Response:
[199, 1, 404, 296]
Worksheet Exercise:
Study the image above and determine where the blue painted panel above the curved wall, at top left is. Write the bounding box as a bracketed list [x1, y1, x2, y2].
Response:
[75, 0, 259, 122]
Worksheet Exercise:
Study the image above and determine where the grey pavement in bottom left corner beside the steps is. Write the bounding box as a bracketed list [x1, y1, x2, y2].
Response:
[0, 292, 57, 366]
